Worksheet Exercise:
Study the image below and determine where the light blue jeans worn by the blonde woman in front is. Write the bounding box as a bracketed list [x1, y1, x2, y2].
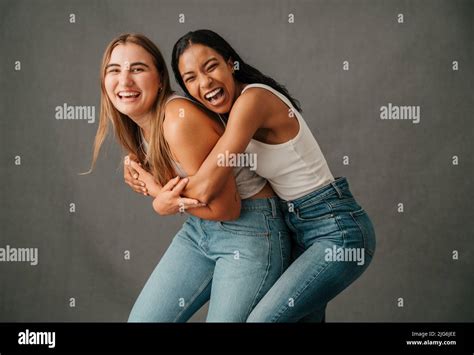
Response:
[128, 197, 291, 322]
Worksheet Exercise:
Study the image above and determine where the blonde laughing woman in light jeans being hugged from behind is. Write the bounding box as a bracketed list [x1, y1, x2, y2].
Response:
[86, 34, 290, 322]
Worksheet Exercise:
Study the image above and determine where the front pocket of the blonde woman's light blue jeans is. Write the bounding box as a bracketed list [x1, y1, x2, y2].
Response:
[218, 211, 270, 237]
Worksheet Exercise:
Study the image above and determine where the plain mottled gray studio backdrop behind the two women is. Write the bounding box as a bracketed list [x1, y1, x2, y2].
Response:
[0, 0, 474, 322]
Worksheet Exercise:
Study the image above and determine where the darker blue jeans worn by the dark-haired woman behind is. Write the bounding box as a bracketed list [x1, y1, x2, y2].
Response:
[247, 178, 375, 322]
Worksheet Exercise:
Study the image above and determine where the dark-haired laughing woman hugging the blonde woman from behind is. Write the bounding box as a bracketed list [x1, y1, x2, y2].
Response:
[139, 30, 375, 322]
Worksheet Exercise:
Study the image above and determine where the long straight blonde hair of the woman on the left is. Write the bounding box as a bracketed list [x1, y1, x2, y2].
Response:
[86, 33, 175, 185]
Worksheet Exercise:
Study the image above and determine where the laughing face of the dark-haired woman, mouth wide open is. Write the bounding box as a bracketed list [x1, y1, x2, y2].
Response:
[178, 44, 241, 113]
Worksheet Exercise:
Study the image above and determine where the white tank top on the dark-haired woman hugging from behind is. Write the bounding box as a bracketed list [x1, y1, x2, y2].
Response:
[242, 84, 334, 201]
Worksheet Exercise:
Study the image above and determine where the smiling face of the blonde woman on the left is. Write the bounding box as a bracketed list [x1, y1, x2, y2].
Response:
[104, 43, 161, 122]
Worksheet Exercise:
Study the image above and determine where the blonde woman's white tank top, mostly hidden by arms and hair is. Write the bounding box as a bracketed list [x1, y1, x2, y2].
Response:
[140, 95, 267, 200]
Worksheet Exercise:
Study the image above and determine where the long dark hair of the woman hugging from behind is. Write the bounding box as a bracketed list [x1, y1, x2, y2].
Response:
[171, 30, 301, 112]
